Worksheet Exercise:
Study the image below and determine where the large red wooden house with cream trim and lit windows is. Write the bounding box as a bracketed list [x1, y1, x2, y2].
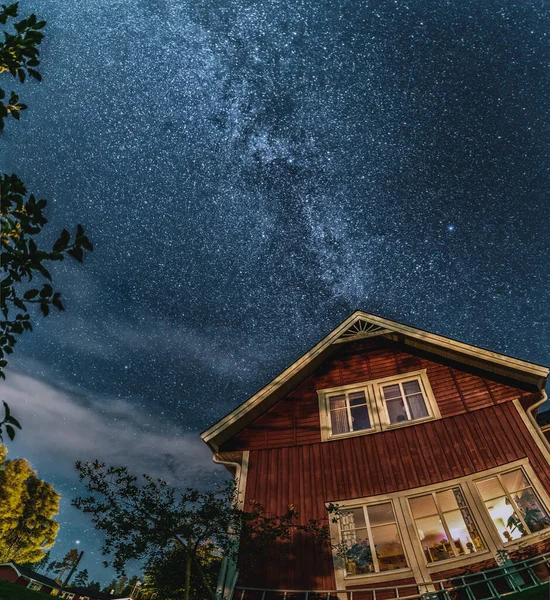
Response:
[202, 312, 550, 590]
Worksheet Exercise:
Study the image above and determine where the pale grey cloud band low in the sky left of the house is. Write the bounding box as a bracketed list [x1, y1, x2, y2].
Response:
[2, 372, 223, 487]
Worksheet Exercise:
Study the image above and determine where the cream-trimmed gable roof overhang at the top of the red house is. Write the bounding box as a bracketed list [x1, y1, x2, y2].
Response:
[201, 310, 549, 452]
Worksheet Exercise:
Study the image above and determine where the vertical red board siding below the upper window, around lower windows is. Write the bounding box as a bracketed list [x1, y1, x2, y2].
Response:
[242, 402, 550, 589]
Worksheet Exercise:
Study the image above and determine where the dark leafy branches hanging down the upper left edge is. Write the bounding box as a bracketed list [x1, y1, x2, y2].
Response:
[0, 3, 93, 441]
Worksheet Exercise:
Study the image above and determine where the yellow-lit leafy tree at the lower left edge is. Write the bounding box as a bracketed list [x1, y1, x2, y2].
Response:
[0, 446, 61, 563]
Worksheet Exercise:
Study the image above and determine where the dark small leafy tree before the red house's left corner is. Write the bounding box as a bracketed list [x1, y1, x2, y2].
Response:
[73, 461, 336, 600]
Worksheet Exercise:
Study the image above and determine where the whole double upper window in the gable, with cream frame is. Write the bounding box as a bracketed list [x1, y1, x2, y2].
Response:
[317, 369, 440, 441]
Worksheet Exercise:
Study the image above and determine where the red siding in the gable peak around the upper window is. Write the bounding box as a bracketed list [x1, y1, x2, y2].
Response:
[221, 340, 531, 451]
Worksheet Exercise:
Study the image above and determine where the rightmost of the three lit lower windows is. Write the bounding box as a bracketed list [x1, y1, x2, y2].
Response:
[476, 468, 550, 542]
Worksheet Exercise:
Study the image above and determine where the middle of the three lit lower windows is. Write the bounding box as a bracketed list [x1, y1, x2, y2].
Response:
[409, 486, 485, 563]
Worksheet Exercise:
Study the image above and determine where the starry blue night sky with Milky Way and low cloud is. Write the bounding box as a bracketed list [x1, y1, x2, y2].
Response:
[0, 0, 550, 582]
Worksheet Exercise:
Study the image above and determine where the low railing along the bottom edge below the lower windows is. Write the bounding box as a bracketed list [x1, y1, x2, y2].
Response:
[230, 553, 550, 600]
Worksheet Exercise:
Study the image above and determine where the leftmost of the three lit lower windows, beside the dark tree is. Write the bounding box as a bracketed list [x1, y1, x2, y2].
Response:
[340, 502, 408, 575]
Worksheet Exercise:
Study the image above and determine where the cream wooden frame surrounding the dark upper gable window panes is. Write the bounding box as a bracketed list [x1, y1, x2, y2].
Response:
[317, 369, 441, 442]
